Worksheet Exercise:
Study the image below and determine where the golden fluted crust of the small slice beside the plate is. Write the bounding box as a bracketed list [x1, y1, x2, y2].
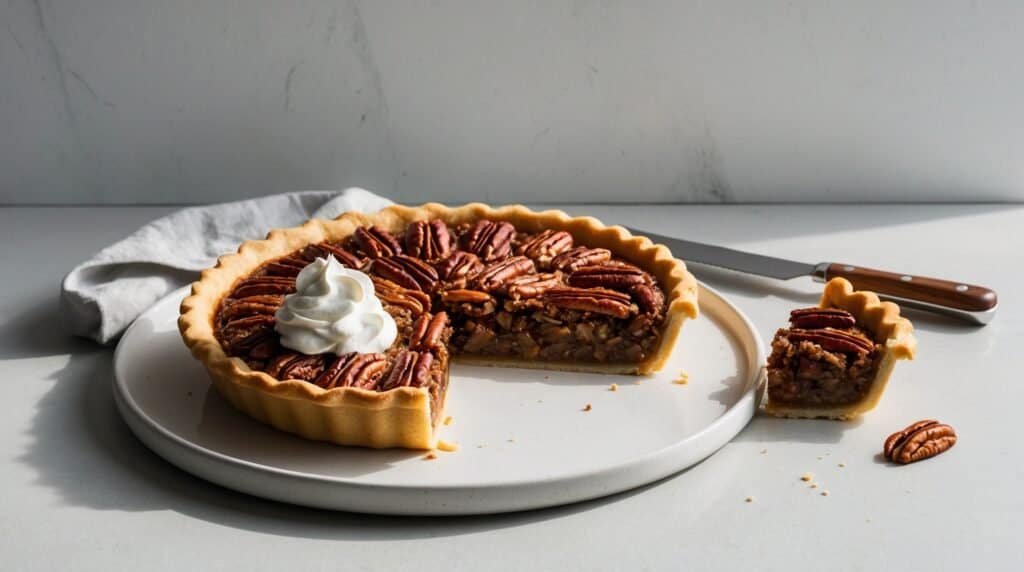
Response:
[765, 277, 918, 421]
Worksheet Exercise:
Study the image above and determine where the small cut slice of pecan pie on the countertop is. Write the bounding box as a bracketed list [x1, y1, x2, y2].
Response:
[765, 278, 916, 420]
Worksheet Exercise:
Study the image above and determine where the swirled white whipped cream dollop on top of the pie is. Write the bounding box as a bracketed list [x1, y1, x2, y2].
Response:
[274, 256, 398, 355]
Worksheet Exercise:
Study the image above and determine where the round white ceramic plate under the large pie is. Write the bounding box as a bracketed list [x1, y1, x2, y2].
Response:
[114, 285, 764, 515]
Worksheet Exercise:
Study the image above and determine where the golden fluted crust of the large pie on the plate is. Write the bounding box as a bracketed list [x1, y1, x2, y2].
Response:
[178, 203, 698, 449]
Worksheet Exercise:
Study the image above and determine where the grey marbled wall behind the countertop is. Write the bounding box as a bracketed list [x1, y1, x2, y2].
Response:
[0, 0, 1024, 204]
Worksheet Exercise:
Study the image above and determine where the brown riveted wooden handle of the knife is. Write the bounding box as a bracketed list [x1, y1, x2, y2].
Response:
[822, 262, 998, 315]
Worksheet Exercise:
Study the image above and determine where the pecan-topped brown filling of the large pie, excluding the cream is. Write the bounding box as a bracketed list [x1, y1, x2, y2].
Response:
[215, 220, 667, 425]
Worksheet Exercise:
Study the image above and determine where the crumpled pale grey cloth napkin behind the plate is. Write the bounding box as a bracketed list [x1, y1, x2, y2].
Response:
[60, 188, 391, 344]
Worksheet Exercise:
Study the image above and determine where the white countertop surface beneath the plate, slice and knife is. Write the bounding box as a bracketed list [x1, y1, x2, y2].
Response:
[0, 206, 1024, 571]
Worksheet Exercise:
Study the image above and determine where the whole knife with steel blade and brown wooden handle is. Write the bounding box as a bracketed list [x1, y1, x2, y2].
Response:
[627, 228, 998, 324]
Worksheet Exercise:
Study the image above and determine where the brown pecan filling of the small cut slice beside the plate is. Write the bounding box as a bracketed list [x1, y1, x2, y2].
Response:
[768, 308, 883, 408]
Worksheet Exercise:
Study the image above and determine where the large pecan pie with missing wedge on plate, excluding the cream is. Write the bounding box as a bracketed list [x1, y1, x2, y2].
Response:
[178, 204, 697, 448]
